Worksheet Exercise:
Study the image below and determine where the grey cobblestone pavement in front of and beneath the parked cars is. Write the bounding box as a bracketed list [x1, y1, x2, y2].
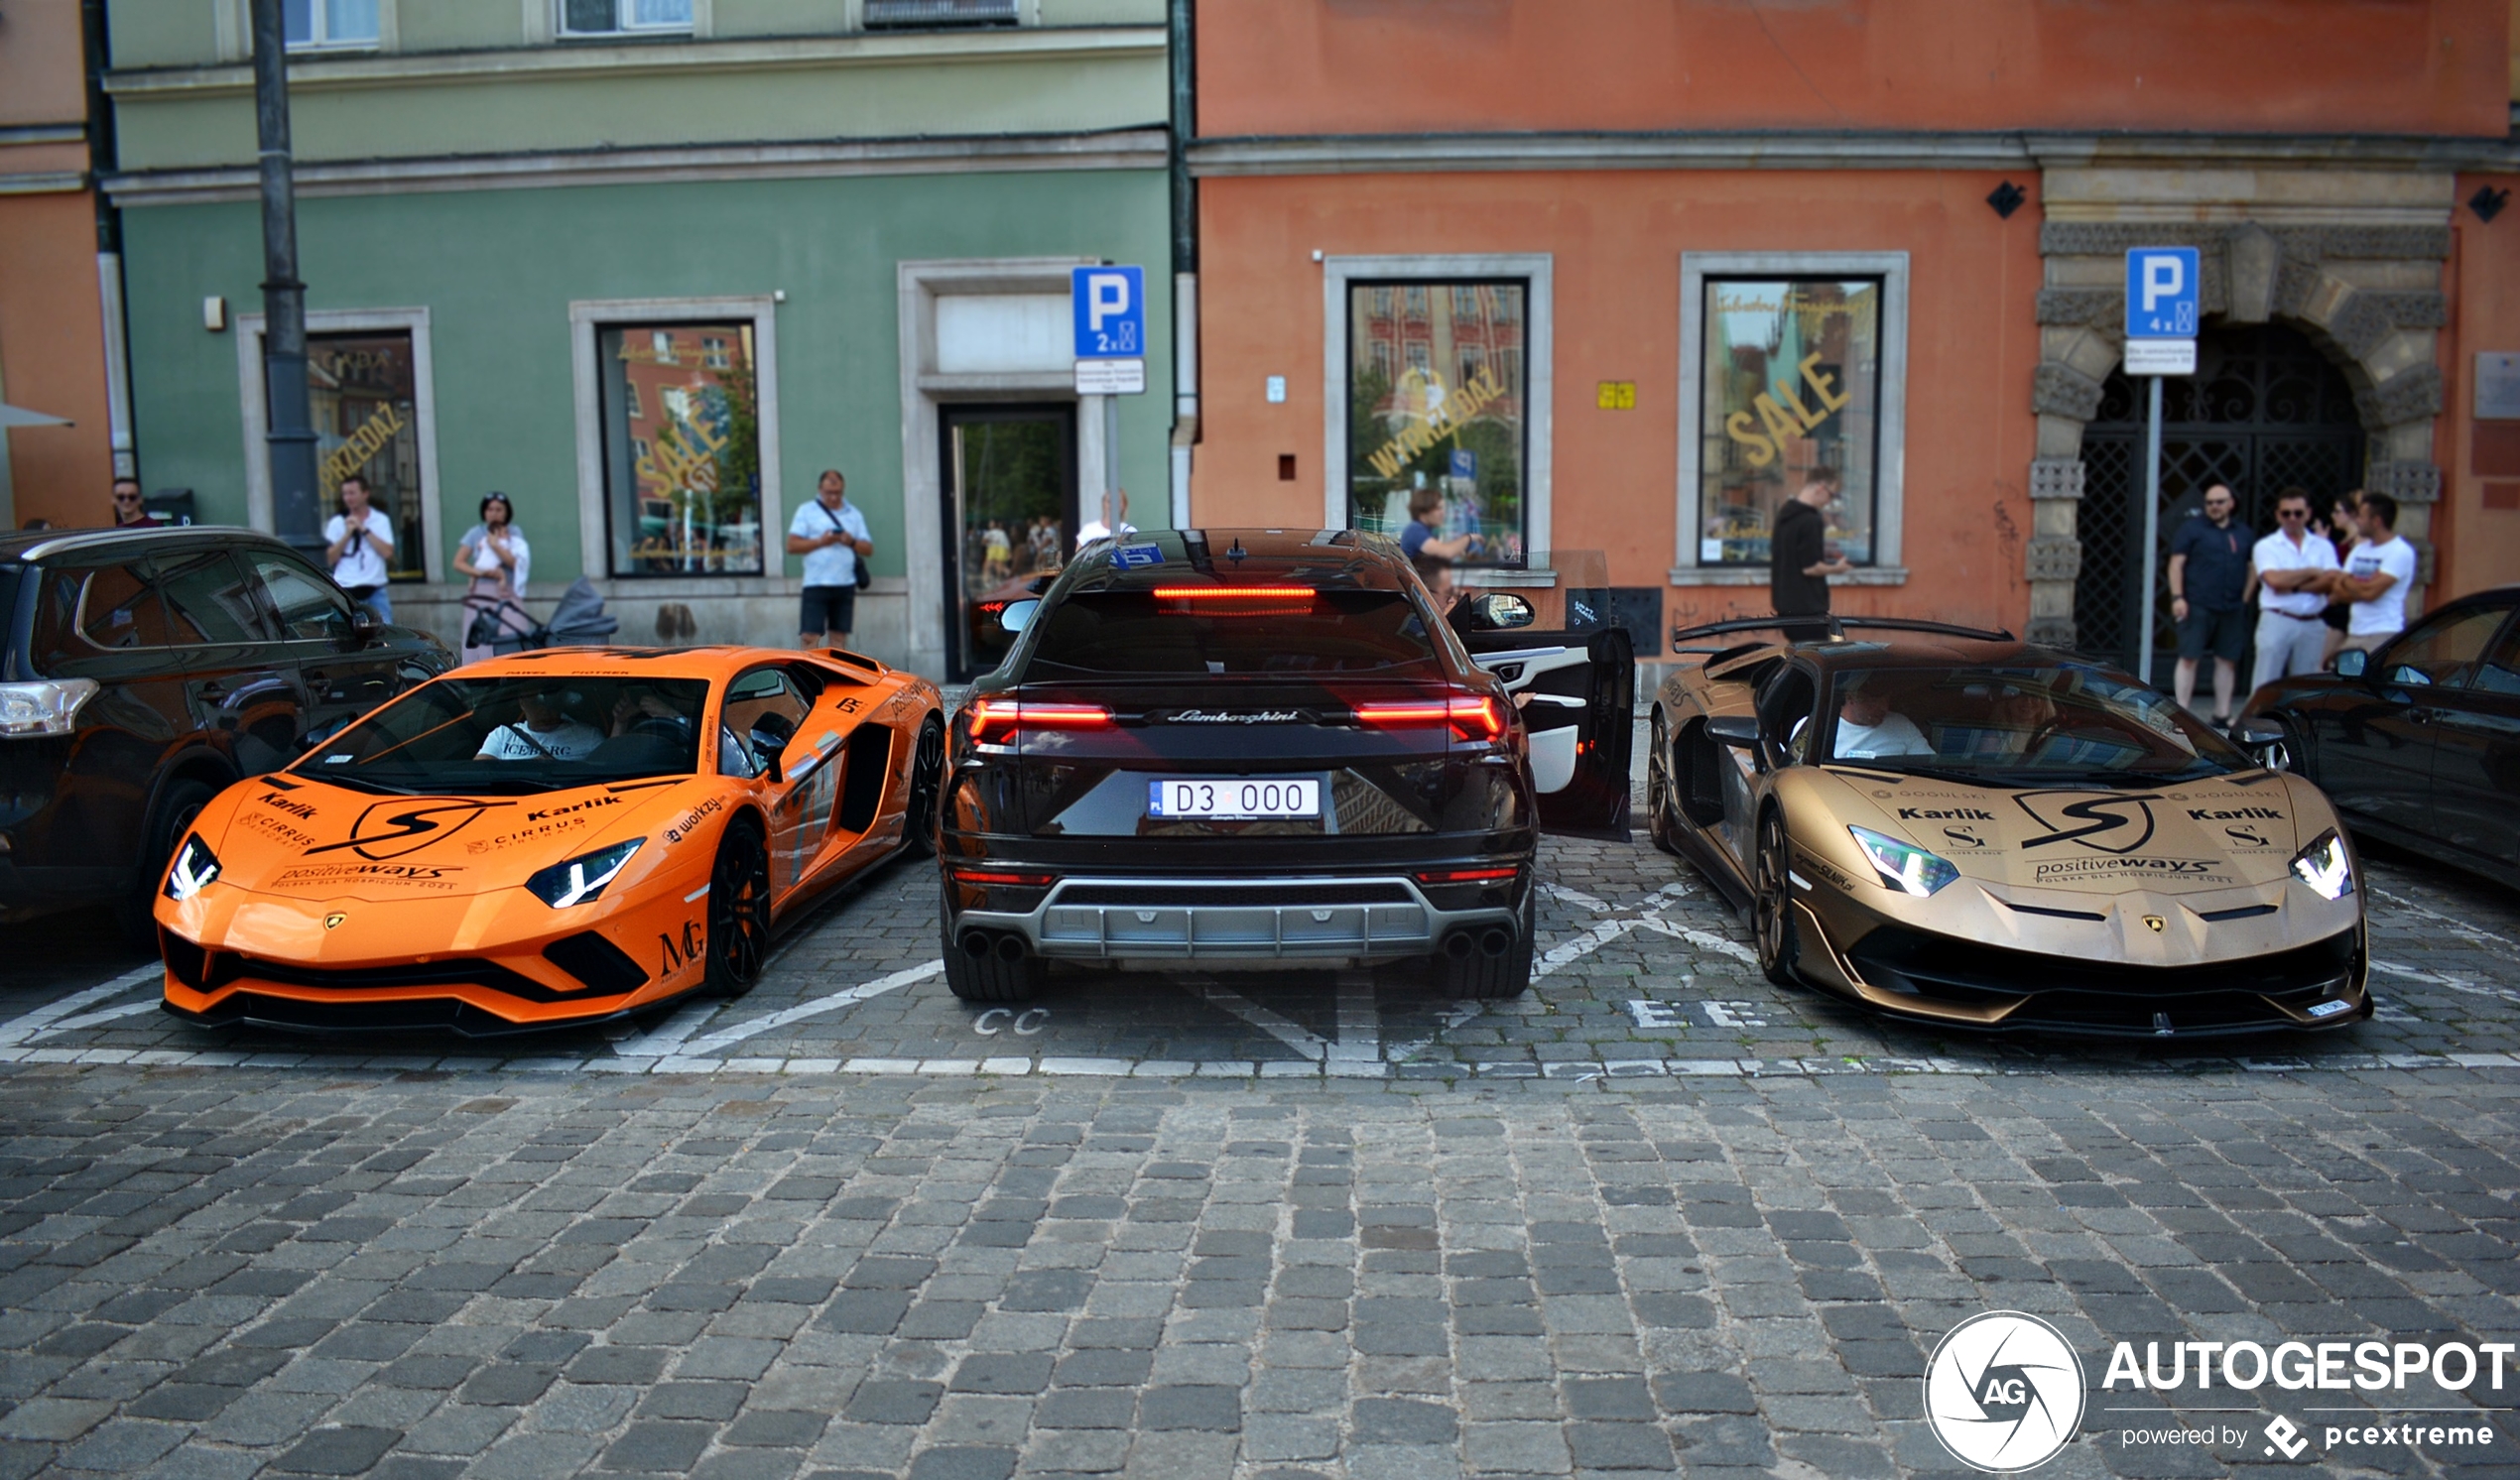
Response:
[0, 797, 2520, 1480]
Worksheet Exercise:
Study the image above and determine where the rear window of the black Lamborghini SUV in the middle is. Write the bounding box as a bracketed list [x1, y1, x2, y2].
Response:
[1026, 585, 1437, 678]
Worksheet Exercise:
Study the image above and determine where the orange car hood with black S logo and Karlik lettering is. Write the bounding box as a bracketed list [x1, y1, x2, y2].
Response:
[199, 777, 698, 900]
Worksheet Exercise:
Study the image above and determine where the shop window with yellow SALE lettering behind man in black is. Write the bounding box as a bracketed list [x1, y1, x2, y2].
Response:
[1696, 278, 1885, 569]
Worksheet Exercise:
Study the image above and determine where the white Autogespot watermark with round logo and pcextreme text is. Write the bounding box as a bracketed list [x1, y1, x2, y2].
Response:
[1926, 1311, 2520, 1475]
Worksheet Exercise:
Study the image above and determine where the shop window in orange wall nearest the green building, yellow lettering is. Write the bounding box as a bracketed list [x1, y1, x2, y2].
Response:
[1345, 280, 1530, 564]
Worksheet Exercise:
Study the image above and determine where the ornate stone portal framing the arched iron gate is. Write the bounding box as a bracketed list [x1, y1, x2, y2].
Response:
[2026, 184, 2452, 646]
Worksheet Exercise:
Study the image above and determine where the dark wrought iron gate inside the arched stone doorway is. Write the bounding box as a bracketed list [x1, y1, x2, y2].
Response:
[2074, 322, 2364, 674]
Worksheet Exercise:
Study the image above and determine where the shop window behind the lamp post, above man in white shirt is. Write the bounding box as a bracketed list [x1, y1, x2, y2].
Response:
[308, 330, 429, 580]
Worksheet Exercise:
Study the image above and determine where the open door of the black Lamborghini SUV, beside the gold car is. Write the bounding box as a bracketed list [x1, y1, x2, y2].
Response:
[1451, 550, 1635, 842]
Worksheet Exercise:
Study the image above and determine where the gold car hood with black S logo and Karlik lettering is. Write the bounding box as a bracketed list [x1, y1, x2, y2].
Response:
[1829, 772, 2333, 895]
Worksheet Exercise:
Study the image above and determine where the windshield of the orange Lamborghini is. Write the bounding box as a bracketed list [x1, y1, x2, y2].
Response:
[293, 674, 708, 795]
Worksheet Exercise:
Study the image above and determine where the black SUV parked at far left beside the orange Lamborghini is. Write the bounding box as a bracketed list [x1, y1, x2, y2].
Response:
[0, 527, 453, 930]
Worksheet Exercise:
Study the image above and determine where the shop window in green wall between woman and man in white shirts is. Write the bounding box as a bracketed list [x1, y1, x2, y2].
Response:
[594, 322, 761, 575]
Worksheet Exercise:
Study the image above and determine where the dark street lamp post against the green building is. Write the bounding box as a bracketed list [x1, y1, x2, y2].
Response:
[252, 0, 322, 555]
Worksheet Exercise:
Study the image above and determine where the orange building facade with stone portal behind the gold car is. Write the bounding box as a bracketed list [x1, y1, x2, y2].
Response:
[1187, 0, 2520, 658]
